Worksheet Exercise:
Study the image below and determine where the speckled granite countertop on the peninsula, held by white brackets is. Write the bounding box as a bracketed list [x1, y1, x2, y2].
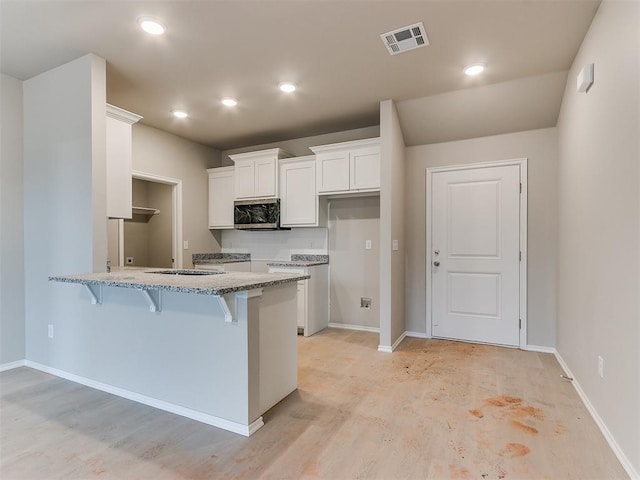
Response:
[49, 267, 310, 295]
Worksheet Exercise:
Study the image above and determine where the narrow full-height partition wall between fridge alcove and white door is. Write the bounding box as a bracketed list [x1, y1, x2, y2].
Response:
[380, 100, 406, 347]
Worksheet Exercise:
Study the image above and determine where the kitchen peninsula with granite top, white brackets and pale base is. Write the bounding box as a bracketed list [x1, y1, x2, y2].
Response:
[49, 267, 309, 436]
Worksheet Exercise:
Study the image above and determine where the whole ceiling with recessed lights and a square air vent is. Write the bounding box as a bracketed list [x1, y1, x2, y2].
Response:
[0, 0, 599, 150]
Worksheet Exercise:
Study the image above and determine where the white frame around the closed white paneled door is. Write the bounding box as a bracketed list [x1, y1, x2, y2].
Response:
[425, 158, 527, 349]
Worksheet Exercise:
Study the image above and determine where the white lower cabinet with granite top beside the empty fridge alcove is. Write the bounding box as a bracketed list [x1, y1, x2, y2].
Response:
[269, 265, 329, 337]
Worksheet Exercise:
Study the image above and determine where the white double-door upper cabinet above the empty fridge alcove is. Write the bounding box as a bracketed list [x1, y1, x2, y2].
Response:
[310, 138, 380, 194]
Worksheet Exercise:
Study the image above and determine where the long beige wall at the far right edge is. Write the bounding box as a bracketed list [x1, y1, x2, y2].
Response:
[558, 0, 640, 475]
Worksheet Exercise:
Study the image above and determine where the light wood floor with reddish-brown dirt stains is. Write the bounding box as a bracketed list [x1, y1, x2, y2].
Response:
[0, 329, 627, 480]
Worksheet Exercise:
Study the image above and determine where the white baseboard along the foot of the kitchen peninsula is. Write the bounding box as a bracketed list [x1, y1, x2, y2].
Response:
[24, 360, 264, 437]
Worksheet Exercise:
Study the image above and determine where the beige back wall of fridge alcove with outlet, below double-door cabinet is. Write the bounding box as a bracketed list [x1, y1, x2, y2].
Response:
[329, 197, 381, 328]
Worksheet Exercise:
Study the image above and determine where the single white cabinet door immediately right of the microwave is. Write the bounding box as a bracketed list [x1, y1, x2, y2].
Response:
[280, 160, 318, 227]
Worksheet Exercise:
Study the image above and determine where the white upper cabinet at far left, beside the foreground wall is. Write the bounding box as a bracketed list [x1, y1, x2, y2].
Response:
[106, 105, 142, 218]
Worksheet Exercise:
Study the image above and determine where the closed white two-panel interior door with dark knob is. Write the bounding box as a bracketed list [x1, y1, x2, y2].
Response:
[430, 165, 521, 346]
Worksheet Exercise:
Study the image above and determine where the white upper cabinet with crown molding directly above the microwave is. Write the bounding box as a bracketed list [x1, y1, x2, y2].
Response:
[229, 148, 291, 199]
